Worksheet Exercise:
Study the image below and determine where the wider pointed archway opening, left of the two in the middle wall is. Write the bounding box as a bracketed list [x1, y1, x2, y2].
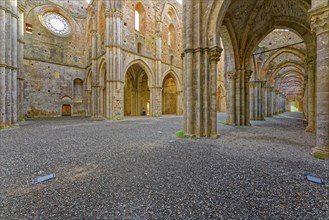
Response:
[124, 64, 150, 116]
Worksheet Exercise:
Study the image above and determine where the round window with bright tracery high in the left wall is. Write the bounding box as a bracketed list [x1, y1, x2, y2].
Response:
[43, 12, 71, 36]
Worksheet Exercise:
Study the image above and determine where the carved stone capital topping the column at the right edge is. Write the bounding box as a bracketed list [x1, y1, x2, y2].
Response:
[309, 6, 329, 35]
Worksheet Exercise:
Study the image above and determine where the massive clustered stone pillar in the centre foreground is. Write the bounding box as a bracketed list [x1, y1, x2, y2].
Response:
[183, 1, 222, 137]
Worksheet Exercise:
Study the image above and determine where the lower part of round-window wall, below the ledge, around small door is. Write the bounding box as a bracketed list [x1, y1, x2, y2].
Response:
[24, 59, 85, 117]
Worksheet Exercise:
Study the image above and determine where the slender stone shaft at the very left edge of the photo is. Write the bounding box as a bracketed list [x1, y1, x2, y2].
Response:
[0, 1, 7, 128]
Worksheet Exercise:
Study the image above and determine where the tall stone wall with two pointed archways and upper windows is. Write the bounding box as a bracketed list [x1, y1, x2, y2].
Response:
[85, 0, 183, 119]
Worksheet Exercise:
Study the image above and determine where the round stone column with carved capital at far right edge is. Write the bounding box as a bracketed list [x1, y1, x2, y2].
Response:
[310, 4, 329, 159]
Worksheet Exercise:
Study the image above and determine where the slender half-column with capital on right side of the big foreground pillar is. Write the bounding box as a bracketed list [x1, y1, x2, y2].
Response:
[209, 47, 222, 138]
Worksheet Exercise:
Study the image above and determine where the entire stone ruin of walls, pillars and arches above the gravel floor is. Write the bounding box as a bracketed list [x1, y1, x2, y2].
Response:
[0, 0, 329, 157]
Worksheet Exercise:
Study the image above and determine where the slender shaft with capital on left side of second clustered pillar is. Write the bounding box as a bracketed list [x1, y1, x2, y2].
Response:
[227, 72, 237, 125]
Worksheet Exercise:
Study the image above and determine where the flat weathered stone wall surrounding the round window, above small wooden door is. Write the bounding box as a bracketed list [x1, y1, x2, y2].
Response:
[24, 0, 87, 117]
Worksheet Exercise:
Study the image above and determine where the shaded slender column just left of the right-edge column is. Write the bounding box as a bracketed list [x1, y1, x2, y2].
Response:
[306, 58, 316, 133]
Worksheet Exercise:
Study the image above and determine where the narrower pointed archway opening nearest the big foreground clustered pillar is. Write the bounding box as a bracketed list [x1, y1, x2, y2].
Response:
[162, 74, 177, 115]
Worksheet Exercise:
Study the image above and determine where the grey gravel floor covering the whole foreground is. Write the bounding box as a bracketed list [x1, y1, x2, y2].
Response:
[0, 113, 329, 219]
